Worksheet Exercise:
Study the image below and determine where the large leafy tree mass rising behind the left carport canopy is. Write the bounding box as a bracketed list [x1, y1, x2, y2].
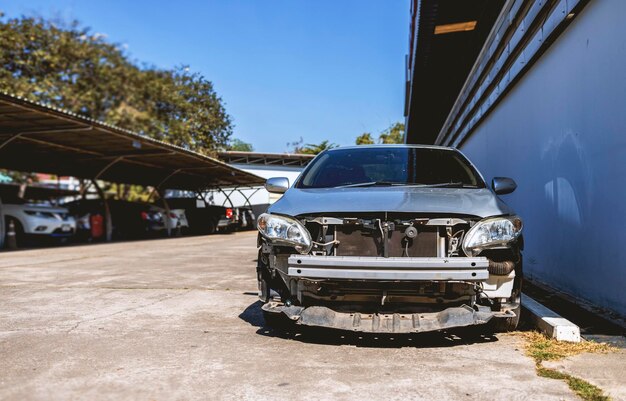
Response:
[0, 16, 232, 153]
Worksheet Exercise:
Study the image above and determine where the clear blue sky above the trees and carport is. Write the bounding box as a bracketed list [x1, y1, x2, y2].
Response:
[0, 0, 409, 152]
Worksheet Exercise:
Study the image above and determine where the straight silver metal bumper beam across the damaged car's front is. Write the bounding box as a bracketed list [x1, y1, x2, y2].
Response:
[288, 255, 489, 281]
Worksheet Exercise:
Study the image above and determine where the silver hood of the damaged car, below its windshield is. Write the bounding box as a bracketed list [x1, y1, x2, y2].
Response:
[268, 187, 513, 217]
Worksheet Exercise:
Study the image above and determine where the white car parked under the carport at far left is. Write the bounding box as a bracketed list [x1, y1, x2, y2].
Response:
[2, 198, 76, 241]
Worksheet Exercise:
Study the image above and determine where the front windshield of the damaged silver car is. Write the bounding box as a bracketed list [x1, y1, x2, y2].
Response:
[296, 147, 485, 188]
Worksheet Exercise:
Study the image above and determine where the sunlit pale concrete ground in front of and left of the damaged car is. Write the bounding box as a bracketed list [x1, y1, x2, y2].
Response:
[0, 232, 616, 400]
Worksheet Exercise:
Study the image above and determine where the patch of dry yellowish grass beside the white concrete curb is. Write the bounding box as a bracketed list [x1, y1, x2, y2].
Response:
[520, 332, 617, 401]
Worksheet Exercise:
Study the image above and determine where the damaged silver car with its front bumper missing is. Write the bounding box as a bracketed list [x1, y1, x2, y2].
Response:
[257, 145, 523, 333]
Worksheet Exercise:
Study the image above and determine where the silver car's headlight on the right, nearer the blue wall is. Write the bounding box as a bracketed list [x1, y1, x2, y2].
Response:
[463, 216, 522, 256]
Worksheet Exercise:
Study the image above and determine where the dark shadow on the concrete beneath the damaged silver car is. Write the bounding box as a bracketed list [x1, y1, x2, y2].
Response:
[239, 301, 498, 348]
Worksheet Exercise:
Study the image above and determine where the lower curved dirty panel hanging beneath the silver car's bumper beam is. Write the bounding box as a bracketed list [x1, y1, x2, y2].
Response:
[263, 302, 515, 333]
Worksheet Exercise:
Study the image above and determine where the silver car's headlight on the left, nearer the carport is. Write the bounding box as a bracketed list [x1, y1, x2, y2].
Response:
[256, 213, 313, 253]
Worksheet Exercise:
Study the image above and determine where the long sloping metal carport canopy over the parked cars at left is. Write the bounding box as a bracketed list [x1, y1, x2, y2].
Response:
[0, 92, 265, 191]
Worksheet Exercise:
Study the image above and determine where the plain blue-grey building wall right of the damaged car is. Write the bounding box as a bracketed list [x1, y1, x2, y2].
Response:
[462, 0, 626, 316]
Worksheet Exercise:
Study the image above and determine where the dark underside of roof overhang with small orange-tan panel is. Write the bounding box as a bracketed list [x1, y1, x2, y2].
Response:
[405, 0, 505, 143]
